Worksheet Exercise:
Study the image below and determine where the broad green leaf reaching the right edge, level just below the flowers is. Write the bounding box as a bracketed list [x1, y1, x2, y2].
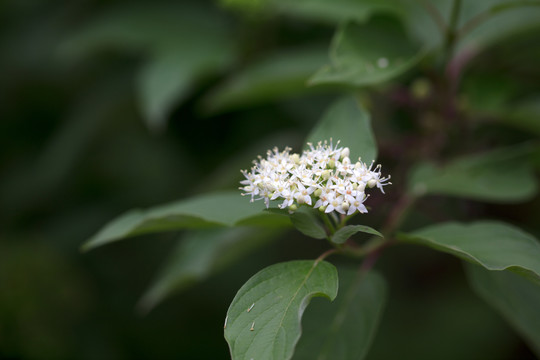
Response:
[398, 221, 540, 283]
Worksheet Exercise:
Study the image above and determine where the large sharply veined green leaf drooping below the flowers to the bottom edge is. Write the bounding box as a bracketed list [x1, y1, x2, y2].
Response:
[225, 260, 338, 360]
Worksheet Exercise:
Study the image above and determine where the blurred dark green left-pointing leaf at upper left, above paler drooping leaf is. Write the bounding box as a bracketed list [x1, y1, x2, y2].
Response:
[60, 3, 228, 58]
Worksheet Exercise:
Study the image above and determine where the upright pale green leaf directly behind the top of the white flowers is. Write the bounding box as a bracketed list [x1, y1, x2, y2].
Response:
[306, 97, 377, 162]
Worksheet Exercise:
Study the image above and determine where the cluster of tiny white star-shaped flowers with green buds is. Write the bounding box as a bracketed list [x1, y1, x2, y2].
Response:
[240, 140, 391, 215]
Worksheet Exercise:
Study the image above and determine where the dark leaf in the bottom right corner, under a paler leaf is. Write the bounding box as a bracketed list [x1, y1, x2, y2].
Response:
[465, 265, 540, 357]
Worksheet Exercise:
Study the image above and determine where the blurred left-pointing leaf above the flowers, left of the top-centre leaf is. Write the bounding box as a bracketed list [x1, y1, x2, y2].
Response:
[203, 47, 327, 112]
